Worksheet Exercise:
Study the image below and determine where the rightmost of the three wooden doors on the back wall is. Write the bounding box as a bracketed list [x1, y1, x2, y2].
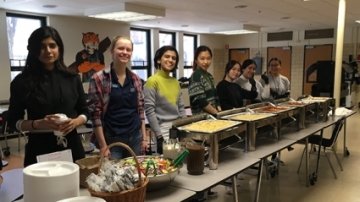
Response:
[303, 44, 333, 95]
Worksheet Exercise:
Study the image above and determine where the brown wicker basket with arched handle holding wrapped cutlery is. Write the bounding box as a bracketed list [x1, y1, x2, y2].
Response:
[89, 142, 149, 202]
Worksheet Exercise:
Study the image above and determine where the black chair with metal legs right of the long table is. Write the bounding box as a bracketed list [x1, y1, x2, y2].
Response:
[297, 118, 345, 179]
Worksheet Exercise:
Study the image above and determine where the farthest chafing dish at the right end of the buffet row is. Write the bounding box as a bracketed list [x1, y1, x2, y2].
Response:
[299, 96, 335, 121]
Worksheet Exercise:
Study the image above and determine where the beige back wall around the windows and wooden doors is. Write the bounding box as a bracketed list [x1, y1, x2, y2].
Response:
[0, 9, 360, 106]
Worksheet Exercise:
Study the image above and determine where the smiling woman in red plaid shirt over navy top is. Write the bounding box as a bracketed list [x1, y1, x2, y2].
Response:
[89, 36, 147, 159]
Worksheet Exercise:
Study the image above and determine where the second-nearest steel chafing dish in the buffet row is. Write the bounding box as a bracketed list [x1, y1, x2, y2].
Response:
[217, 108, 279, 151]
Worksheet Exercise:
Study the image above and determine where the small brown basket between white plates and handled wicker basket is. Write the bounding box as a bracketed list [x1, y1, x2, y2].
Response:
[75, 156, 100, 188]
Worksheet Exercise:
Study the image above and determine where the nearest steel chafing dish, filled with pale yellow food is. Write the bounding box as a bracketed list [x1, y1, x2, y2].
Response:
[172, 114, 246, 170]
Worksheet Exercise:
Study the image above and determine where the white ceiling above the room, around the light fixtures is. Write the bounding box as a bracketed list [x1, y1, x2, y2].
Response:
[0, 0, 360, 33]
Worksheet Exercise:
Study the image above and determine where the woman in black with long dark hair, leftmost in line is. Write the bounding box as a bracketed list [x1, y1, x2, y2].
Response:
[8, 26, 88, 166]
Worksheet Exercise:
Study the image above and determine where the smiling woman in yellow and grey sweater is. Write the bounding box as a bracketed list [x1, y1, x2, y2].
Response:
[144, 46, 186, 154]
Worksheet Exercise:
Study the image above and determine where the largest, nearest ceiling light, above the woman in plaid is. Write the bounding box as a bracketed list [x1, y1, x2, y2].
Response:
[85, 2, 165, 22]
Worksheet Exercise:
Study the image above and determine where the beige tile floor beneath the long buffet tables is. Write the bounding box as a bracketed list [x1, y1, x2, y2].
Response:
[0, 110, 360, 202]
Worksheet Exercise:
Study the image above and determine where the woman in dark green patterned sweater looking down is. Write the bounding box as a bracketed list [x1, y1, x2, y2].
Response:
[189, 46, 221, 114]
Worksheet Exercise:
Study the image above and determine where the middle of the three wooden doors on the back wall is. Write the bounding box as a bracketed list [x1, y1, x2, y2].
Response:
[266, 46, 292, 83]
